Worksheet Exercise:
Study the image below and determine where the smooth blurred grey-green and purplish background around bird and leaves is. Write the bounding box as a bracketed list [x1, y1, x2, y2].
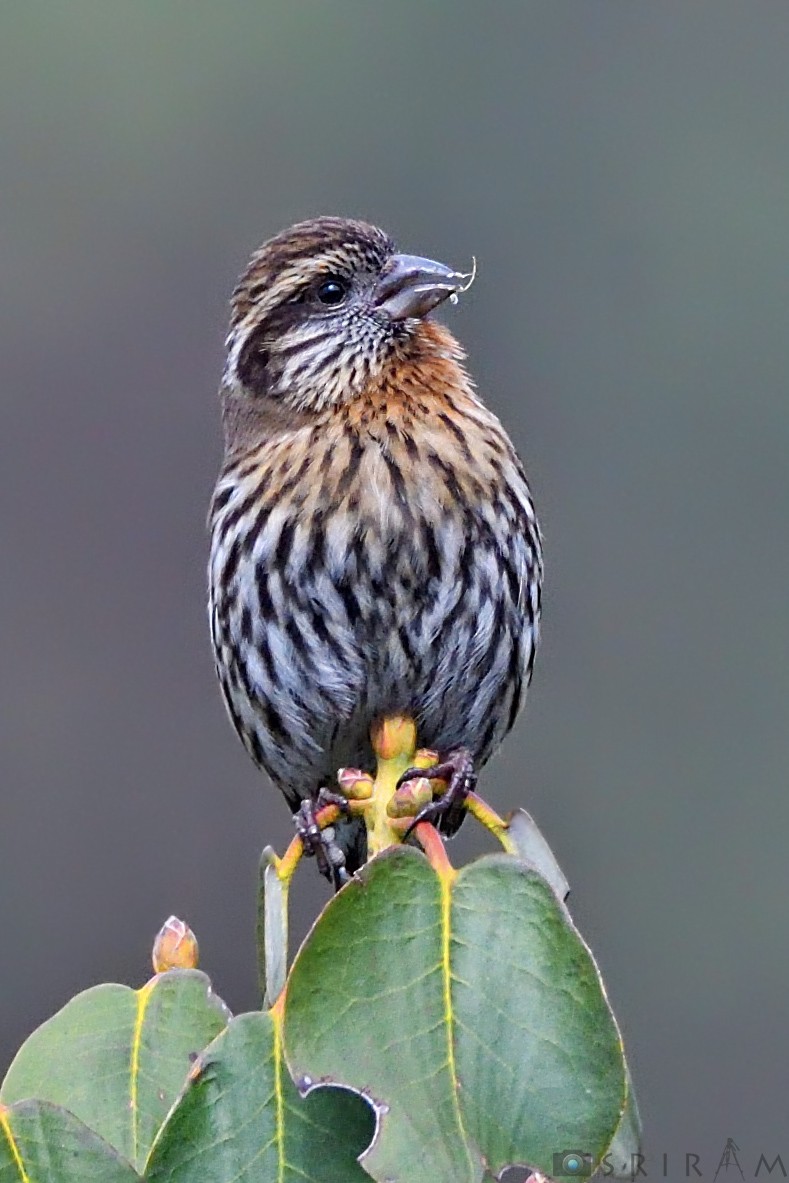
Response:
[0, 0, 789, 1179]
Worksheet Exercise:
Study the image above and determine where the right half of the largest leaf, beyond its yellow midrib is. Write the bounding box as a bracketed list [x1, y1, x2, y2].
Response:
[452, 855, 626, 1174]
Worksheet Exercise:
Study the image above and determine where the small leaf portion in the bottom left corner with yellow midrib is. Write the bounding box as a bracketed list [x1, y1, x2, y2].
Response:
[0, 1100, 142, 1183]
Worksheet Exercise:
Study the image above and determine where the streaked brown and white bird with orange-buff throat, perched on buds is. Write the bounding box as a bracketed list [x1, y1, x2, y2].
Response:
[208, 216, 543, 887]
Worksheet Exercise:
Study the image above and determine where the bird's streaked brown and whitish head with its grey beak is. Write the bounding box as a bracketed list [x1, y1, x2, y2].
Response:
[224, 218, 468, 413]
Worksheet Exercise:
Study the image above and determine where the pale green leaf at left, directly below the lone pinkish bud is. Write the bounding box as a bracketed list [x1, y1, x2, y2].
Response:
[0, 970, 229, 1181]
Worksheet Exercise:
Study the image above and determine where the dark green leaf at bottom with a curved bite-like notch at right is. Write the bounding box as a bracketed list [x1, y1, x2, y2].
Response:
[145, 1010, 375, 1183]
